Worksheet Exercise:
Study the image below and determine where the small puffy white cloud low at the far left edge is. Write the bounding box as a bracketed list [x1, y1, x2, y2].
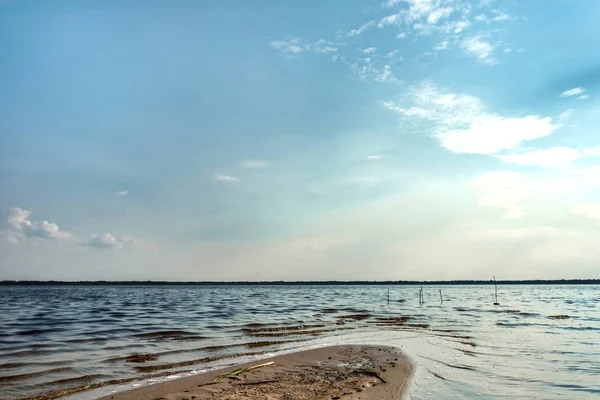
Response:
[8, 207, 70, 242]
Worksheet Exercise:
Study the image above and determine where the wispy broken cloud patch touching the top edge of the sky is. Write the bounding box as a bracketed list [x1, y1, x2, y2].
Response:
[270, 0, 518, 77]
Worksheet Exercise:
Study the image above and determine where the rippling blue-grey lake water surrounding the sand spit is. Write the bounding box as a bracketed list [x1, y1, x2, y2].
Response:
[0, 285, 600, 400]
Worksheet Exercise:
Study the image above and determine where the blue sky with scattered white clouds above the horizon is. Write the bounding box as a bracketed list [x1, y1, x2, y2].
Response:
[0, 0, 600, 281]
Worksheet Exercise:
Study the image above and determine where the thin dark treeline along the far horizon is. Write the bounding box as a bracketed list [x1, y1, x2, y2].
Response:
[0, 279, 600, 286]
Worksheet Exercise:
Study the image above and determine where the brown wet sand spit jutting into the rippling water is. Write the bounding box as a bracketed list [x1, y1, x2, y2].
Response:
[101, 346, 413, 400]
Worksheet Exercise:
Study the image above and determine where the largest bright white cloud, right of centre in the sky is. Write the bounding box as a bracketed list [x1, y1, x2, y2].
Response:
[383, 82, 558, 155]
